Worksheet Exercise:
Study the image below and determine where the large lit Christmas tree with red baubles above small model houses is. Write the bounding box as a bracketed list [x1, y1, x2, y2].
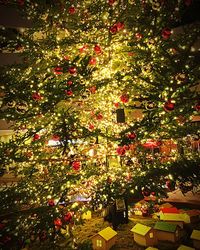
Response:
[0, 0, 200, 249]
